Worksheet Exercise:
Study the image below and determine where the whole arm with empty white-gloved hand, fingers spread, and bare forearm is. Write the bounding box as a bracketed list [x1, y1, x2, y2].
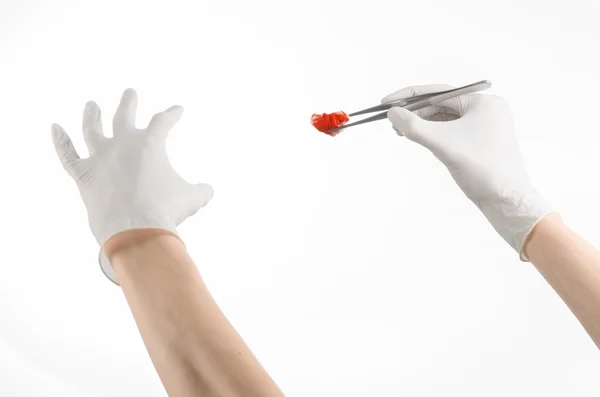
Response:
[52, 89, 284, 397]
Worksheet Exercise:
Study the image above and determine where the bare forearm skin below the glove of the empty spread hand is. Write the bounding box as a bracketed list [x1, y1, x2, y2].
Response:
[104, 229, 283, 397]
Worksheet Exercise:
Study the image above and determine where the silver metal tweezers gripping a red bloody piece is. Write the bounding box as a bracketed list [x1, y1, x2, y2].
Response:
[330, 80, 492, 132]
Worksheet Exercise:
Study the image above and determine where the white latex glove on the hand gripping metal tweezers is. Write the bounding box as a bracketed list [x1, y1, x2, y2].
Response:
[382, 85, 552, 261]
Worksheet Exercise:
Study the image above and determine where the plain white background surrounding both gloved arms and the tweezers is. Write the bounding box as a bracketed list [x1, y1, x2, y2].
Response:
[0, 0, 600, 397]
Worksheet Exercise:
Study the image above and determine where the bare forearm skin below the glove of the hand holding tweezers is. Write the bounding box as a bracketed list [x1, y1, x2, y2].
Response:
[525, 215, 600, 348]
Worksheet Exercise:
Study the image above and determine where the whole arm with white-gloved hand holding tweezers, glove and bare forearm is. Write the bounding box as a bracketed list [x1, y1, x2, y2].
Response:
[382, 85, 600, 345]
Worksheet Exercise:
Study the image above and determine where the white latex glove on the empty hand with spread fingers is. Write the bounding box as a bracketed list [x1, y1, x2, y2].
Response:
[52, 89, 213, 285]
